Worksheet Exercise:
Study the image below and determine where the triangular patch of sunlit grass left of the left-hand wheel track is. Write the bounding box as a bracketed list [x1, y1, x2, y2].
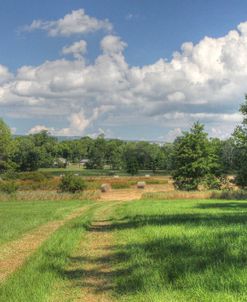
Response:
[0, 200, 85, 244]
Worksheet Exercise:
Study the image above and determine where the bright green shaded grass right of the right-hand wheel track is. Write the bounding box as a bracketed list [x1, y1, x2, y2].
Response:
[107, 200, 247, 302]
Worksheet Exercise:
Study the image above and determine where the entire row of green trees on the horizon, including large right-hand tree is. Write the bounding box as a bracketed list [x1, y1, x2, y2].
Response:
[0, 97, 247, 190]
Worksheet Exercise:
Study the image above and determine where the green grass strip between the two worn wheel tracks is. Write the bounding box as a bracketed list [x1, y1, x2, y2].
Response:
[0, 205, 98, 302]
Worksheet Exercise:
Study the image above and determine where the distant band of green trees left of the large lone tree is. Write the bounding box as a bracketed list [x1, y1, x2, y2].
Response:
[0, 120, 172, 174]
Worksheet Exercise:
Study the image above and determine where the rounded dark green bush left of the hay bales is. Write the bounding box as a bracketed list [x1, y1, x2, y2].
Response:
[59, 174, 86, 193]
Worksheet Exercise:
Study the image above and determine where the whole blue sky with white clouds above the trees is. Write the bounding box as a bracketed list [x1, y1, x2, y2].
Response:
[0, 0, 247, 141]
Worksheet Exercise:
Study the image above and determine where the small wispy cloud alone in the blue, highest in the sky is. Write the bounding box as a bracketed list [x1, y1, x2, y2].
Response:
[22, 9, 113, 37]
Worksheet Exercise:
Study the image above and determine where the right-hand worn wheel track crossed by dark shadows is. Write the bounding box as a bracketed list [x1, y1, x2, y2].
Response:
[51, 202, 120, 302]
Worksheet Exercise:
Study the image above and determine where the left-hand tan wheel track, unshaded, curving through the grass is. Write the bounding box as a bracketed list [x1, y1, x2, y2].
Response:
[0, 206, 89, 282]
